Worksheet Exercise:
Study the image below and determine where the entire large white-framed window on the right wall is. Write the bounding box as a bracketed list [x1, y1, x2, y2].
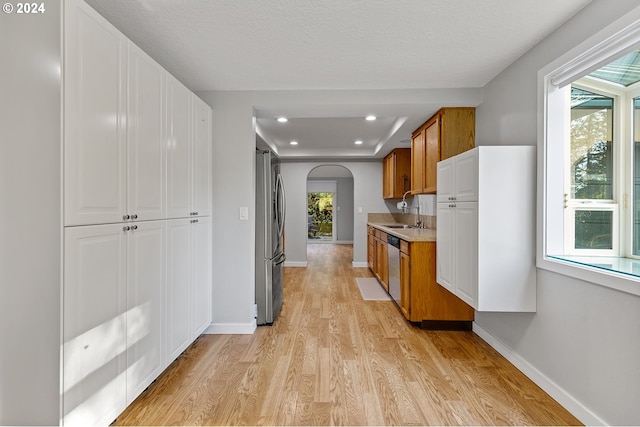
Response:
[538, 8, 640, 295]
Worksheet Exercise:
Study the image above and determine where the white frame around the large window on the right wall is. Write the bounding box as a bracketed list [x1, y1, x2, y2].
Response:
[536, 7, 640, 296]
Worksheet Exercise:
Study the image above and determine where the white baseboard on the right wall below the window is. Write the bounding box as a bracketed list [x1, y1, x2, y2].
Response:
[473, 322, 608, 426]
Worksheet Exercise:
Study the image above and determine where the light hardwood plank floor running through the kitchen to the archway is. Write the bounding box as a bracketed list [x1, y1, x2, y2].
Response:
[114, 244, 580, 426]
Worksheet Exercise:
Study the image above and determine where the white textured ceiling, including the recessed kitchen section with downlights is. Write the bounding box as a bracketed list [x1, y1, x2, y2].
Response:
[86, 0, 590, 157]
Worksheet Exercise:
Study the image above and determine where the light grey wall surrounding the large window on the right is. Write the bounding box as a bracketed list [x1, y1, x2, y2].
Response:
[476, 0, 640, 425]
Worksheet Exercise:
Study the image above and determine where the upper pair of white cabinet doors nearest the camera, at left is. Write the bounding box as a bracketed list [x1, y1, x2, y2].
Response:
[64, 0, 166, 225]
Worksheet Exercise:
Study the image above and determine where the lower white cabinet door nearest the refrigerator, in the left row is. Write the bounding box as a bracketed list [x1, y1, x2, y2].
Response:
[191, 217, 212, 338]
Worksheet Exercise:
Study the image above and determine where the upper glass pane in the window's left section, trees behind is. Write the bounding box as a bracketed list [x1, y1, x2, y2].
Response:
[569, 87, 613, 201]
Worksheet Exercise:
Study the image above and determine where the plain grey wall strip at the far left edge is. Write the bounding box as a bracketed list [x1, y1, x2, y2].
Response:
[0, 0, 61, 425]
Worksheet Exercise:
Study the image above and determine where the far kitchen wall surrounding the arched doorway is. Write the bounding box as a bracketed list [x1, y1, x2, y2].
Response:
[281, 161, 388, 267]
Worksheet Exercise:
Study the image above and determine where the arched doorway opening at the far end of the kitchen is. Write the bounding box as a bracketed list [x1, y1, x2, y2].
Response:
[306, 165, 354, 243]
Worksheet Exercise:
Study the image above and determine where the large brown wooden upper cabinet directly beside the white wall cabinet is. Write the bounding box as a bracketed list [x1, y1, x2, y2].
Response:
[411, 107, 476, 194]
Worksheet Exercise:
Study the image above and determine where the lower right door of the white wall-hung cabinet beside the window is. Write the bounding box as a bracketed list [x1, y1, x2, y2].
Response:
[452, 202, 478, 307]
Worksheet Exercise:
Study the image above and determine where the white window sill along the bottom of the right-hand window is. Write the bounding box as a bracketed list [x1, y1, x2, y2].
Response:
[538, 255, 640, 296]
